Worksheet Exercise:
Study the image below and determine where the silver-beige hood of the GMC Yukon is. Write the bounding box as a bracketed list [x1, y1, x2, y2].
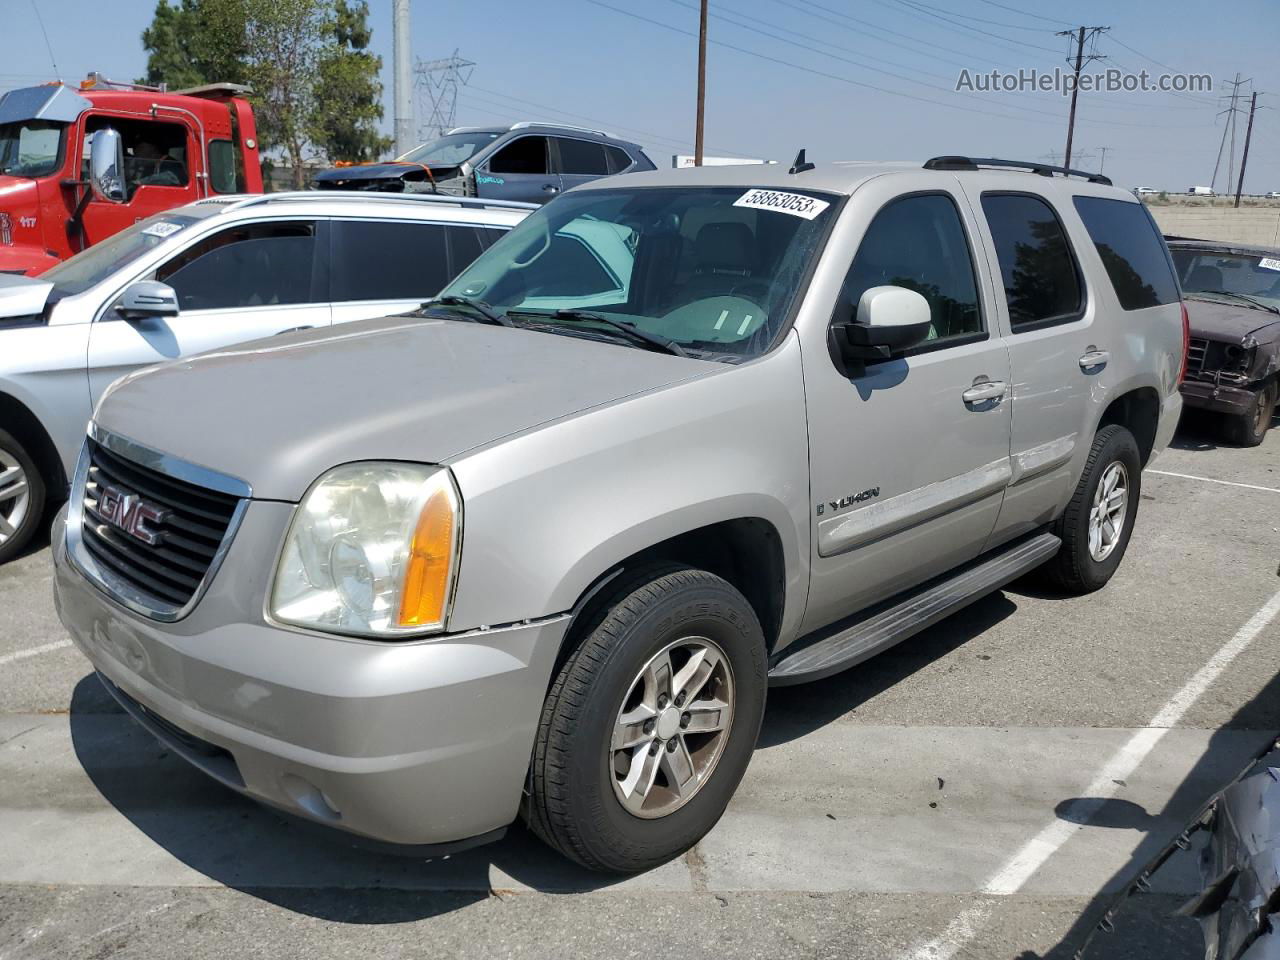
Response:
[93, 316, 721, 502]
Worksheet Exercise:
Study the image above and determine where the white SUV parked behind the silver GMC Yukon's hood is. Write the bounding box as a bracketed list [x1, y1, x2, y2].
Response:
[0, 192, 535, 563]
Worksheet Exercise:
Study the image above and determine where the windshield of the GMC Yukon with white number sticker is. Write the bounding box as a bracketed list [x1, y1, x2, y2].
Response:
[442, 187, 833, 358]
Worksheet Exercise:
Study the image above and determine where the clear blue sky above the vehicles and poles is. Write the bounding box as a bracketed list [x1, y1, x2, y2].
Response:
[0, 0, 1280, 192]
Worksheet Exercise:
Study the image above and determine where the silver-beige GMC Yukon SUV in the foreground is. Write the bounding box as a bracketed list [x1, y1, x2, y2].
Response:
[54, 155, 1187, 872]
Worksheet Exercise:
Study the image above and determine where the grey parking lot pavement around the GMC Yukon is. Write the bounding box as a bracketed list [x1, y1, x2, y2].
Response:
[0, 414, 1280, 960]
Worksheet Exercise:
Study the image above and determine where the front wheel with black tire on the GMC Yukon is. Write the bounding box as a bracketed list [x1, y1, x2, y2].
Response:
[524, 564, 767, 873]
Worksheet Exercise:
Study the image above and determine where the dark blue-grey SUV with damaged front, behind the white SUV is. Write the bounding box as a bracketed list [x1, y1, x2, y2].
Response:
[314, 122, 654, 204]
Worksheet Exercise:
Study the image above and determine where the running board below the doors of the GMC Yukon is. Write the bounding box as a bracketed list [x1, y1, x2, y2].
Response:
[769, 534, 1062, 686]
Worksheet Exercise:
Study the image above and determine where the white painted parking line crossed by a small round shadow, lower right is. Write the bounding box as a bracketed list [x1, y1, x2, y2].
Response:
[906, 593, 1280, 960]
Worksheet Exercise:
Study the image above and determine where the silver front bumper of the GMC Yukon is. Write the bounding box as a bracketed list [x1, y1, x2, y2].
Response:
[52, 502, 568, 852]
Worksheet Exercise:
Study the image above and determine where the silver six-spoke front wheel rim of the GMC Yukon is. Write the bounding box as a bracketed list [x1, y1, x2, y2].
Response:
[607, 636, 733, 819]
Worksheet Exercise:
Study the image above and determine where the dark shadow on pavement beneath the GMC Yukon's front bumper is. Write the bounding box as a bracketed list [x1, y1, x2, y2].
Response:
[70, 673, 623, 924]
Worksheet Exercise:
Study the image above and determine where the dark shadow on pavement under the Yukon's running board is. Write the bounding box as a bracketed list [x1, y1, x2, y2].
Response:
[756, 591, 1018, 749]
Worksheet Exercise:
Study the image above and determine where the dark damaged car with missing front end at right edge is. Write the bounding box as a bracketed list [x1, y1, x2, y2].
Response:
[1166, 237, 1280, 447]
